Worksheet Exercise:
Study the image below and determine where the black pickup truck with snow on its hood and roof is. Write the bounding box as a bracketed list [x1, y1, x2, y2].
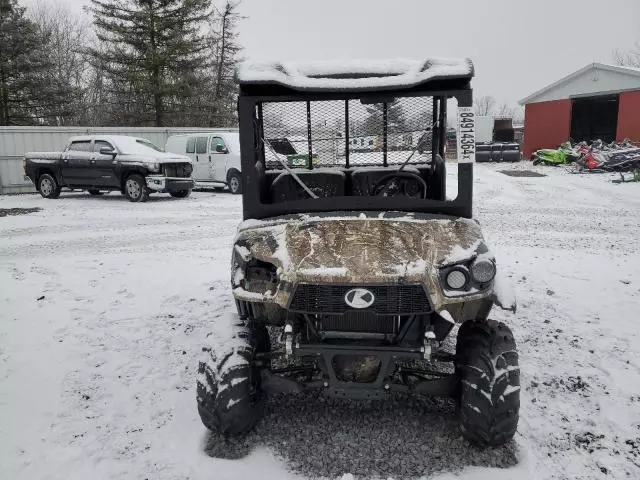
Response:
[24, 135, 194, 202]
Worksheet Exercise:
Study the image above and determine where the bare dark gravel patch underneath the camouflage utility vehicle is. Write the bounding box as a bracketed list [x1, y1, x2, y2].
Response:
[205, 391, 518, 478]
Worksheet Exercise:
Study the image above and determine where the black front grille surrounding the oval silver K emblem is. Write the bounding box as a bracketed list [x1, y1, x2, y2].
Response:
[289, 283, 431, 315]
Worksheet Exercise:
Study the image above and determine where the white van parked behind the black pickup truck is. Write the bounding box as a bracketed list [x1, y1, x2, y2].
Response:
[165, 129, 242, 194]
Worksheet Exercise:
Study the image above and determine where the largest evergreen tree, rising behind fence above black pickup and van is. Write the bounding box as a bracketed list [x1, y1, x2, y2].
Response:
[90, 0, 210, 126]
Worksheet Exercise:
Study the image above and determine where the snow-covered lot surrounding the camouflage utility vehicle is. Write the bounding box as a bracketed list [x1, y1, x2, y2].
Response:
[0, 163, 640, 480]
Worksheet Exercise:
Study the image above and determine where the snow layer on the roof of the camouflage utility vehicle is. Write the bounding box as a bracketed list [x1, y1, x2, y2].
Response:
[238, 58, 474, 90]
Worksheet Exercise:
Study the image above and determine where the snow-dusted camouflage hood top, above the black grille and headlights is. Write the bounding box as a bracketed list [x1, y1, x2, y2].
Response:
[236, 215, 486, 283]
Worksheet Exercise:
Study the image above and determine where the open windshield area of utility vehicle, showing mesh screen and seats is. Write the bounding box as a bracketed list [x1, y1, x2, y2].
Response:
[261, 97, 444, 203]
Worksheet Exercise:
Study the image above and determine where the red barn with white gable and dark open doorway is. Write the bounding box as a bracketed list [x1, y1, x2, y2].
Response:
[520, 63, 640, 158]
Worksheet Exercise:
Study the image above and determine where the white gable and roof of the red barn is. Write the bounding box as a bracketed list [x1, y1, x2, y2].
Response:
[518, 62, 640, 105]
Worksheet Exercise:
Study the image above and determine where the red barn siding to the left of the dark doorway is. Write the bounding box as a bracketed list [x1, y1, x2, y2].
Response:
[523, 99, 571, 158]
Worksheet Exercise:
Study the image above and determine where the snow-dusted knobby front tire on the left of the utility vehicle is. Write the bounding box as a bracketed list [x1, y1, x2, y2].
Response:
[196, 327, 269, 436]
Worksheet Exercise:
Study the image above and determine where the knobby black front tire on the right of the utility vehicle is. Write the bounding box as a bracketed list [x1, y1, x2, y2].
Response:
[456, 320, 520, 446]
